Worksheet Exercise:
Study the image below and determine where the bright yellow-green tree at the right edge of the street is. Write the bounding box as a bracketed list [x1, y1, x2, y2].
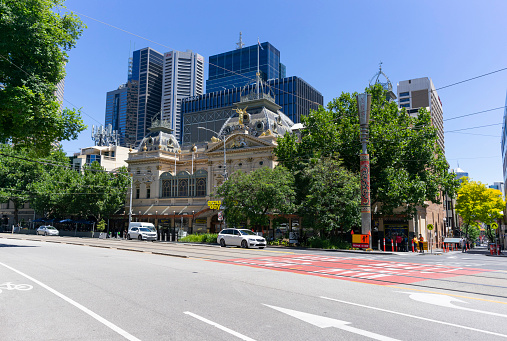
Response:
[456, 177, 505, 239]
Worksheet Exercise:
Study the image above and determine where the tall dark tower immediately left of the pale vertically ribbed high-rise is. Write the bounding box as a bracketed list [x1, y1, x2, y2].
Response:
[129, 47, 164, 144]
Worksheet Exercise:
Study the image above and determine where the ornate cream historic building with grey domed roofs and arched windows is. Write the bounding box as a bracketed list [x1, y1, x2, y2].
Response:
[125, 76, 294, 235]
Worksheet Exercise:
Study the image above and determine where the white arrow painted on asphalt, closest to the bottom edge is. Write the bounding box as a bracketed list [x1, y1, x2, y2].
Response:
[264, 304, 399, 341]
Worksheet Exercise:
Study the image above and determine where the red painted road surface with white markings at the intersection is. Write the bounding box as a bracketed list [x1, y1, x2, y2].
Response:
[213, 255, 489, 285]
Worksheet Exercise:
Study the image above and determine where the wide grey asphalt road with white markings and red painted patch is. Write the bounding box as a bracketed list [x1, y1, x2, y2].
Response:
[0, 234, 507, 341]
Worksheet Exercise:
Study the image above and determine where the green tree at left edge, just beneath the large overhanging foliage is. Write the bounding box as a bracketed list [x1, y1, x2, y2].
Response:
[0, 144, 68, 223]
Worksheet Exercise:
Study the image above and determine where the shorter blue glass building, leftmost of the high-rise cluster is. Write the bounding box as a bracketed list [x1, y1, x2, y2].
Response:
[105, 80, 139, 147]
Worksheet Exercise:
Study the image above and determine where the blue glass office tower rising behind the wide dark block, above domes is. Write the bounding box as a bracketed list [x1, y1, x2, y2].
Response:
[206, 42, 285, 93]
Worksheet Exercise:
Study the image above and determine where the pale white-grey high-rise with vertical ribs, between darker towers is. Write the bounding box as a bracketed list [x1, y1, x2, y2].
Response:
[162, 50, 204, 140]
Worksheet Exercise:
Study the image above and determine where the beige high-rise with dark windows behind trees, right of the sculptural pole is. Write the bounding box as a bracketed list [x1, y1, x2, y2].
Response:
[398, 77, 445, 153]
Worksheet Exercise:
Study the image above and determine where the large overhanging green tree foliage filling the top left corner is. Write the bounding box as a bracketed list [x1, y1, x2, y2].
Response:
[0, 0, 86, 154]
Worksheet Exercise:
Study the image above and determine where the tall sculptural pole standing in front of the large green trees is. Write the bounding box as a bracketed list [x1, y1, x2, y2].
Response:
[357, 93, 371, 248]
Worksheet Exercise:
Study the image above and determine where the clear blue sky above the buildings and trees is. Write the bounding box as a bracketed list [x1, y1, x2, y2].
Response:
[63, 0, 507, 184]
